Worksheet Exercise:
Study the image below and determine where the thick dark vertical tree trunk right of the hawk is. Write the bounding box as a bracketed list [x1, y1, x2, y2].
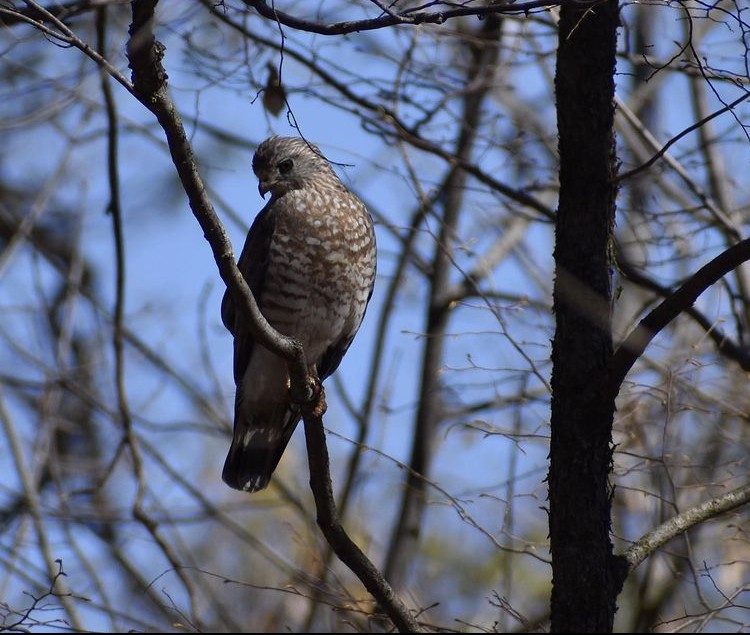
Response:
[549, 0, 622, 633]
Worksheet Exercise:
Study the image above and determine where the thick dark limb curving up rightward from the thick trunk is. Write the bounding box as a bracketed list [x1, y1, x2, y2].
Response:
[608, 238, 750, 399]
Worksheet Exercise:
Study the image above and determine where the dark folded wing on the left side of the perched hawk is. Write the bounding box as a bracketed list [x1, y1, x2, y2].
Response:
[221, 201, 274, 385]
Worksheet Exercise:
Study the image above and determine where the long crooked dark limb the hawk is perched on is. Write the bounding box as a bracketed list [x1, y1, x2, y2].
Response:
[128, 0, 421, 632]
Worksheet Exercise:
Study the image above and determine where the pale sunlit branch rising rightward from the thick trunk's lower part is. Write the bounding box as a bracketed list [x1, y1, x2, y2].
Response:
[623, 484, 750, 571]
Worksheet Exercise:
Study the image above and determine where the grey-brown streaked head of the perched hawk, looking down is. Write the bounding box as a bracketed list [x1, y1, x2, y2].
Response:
[253, 137, 333, 198]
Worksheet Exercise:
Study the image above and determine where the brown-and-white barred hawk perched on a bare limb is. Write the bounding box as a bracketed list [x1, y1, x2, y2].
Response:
[221, 136, 376, 492]
